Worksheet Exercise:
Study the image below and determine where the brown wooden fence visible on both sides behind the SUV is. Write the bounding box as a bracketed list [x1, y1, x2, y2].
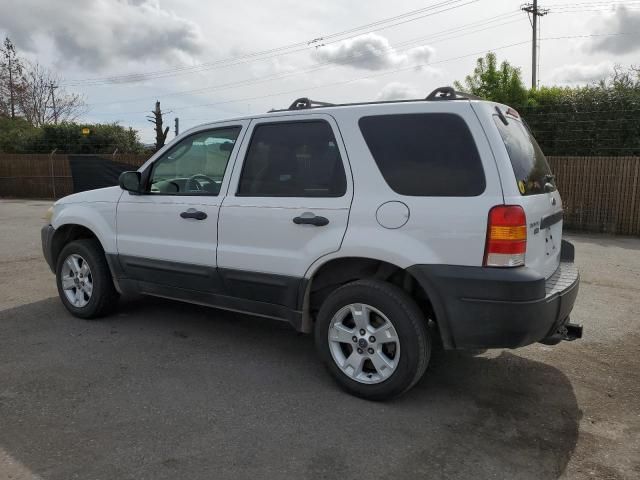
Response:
[0, 154, 640, 235]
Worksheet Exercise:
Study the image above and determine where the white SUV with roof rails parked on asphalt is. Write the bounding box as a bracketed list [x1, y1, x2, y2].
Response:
[42, 87, 582, 399]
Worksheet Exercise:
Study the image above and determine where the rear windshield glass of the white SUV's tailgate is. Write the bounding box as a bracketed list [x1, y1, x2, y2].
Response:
[493, 115, 555, 195]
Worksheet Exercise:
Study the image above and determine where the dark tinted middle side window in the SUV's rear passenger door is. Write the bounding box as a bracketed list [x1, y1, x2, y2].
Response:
[237, 120, 347, 197]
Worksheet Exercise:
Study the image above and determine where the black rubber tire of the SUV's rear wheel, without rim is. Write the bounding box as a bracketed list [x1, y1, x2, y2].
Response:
[315, 280, 431, 400]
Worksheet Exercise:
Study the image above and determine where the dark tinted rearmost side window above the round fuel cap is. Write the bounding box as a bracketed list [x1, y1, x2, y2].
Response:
[359, 113, 485, 197]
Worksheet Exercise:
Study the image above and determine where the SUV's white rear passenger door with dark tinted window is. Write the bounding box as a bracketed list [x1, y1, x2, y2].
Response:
[218, 114, 353, 308]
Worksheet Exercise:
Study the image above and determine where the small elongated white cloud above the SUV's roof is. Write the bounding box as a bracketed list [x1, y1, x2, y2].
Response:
[314, 33, 434, 70]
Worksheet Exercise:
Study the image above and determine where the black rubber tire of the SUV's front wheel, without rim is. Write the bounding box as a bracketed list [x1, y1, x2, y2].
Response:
[56, 239, 119, 320]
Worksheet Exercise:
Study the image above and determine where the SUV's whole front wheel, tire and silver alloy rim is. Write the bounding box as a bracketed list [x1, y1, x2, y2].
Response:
[56, 239, 118, 319]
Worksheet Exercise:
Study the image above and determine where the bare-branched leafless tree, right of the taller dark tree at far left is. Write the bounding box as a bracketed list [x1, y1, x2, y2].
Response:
[19, 63, 85, 127]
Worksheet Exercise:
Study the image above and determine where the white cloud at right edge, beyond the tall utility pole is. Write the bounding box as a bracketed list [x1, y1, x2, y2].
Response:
[587, 6, 640, 55]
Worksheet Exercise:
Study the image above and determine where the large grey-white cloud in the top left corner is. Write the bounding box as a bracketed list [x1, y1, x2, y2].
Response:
[0, 0, 203, 70]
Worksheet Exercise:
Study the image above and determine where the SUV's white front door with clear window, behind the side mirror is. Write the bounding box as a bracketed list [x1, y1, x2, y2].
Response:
[117, 122, 248, 293]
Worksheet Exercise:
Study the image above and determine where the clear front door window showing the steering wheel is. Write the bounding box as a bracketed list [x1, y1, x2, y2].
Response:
[149, 127, 241, 195]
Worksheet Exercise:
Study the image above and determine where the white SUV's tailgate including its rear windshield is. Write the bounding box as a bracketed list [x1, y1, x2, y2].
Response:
[493, 107, 562, 278]
